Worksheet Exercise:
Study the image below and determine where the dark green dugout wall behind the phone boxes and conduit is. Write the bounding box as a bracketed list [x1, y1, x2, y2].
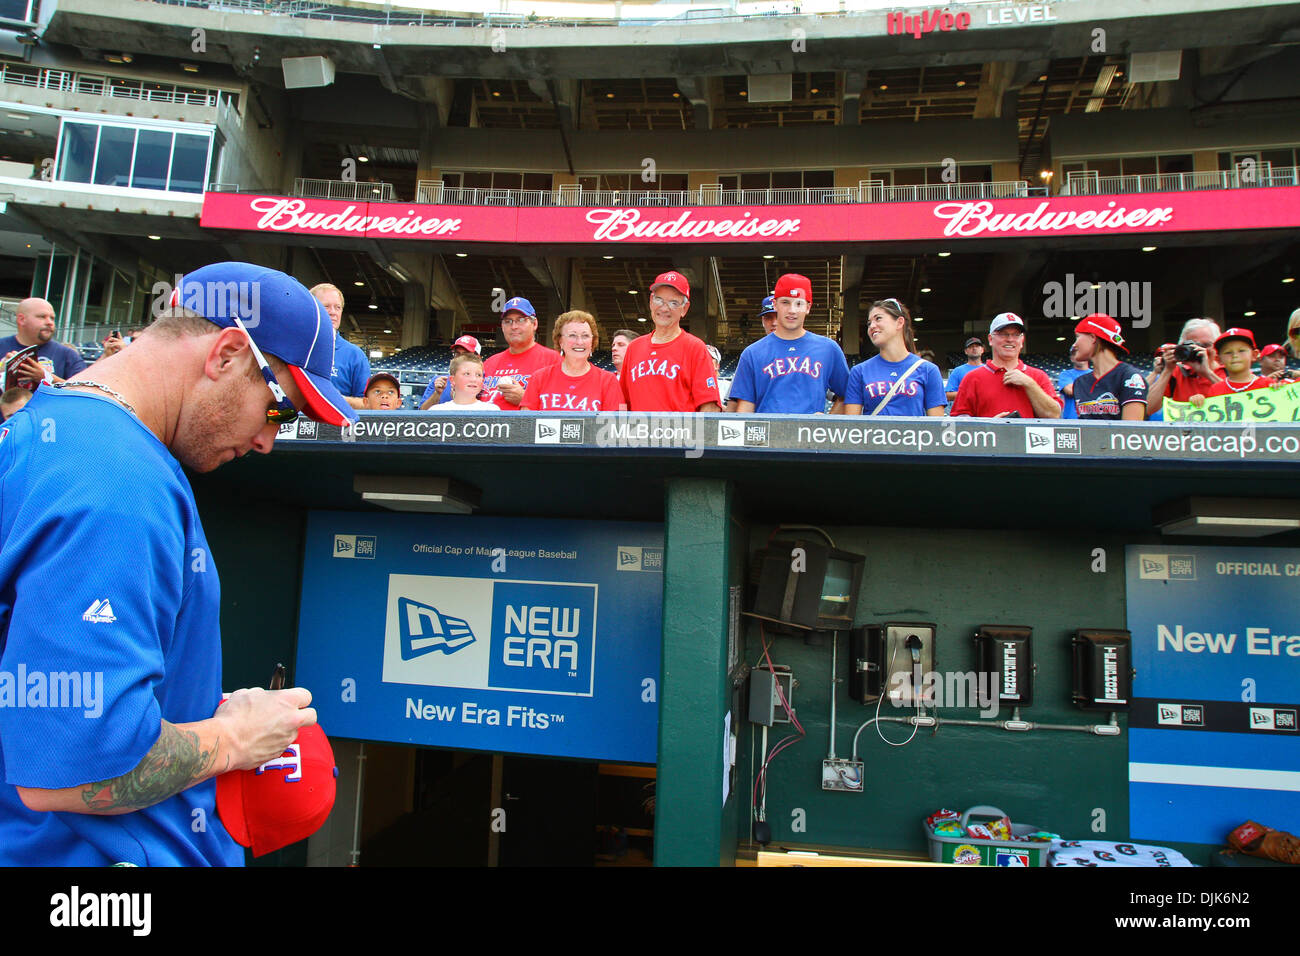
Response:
[738, 528, 1154, 852]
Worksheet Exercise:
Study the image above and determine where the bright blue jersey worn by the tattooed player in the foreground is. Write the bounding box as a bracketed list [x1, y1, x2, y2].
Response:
[0, 386, 243, 866]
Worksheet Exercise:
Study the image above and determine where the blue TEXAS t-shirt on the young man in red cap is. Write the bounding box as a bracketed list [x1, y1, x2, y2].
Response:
[728, 332, 849, 415]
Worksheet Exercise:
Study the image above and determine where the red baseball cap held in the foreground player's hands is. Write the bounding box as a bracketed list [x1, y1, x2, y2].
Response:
[217, 723, 338, 856]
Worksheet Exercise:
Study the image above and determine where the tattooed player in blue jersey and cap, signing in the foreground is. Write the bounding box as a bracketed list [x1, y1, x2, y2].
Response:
[0, 263, 356, 866]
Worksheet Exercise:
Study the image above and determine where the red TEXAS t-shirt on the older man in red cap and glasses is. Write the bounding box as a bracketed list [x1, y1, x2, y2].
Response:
[620, 332, 722, 411]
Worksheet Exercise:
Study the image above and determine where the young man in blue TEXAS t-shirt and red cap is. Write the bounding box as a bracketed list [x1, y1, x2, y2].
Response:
[731, 273, 849, 415]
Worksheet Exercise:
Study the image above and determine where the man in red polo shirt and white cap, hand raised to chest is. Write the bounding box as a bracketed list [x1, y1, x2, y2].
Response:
[953, 312, 1065, 419]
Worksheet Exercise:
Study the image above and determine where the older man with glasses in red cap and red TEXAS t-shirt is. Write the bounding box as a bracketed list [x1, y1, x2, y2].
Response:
[620, 272, 722, 411]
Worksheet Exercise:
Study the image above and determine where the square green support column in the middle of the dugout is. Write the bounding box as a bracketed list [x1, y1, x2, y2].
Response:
[654, 479, 745, 866]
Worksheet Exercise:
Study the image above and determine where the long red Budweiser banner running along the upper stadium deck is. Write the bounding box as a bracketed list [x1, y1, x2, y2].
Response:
[199, 186, 1300, 244]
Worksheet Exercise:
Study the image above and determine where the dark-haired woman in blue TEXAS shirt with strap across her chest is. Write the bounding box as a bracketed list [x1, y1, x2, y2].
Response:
[844, 299, 948, 416]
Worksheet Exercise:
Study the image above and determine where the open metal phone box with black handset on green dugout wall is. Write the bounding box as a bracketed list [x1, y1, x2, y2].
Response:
[849, 622, 935, 708]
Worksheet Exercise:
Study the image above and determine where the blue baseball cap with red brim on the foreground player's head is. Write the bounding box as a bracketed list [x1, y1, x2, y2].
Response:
[170, 263, 358, 427]
